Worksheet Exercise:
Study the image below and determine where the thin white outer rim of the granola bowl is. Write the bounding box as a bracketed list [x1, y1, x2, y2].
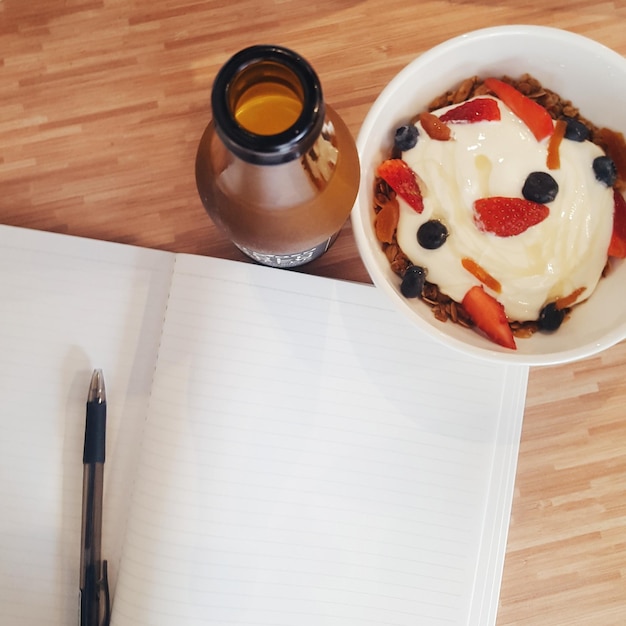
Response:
[351, 24, 626, 366]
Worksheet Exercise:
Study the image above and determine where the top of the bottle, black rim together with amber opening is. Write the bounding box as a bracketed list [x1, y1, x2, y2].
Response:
[211, 46, 325, 165]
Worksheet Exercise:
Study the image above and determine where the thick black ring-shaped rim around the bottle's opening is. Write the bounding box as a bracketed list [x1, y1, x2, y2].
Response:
[211, 45, 325, 165]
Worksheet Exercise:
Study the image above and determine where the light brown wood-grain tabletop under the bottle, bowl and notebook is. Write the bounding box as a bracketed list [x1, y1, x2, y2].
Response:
[0, 0, 626, 626]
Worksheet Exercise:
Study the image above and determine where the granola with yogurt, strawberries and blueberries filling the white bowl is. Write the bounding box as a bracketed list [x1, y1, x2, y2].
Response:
[374, 75, 626, 349]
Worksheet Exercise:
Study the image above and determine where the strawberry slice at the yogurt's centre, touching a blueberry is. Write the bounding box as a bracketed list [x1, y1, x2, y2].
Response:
[474, 196, 550, 237]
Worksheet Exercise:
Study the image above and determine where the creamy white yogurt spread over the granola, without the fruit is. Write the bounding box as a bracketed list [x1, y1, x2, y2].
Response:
[396, 98, 613, 322]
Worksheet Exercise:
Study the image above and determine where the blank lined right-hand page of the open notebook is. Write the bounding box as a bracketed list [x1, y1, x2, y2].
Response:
[113, 255, 527, 626]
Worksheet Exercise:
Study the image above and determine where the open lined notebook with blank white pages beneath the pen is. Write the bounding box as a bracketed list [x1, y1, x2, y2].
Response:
[0, 226, 528, 626]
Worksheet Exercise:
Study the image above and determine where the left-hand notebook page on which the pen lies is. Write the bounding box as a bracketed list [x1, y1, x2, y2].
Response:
[0, 226, 174, 626]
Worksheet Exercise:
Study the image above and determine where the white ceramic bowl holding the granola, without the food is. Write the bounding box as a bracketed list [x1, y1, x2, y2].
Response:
[351, 26, 626, 365]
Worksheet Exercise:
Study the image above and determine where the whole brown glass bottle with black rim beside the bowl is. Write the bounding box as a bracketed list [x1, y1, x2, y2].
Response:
[196, 45, 360, 267]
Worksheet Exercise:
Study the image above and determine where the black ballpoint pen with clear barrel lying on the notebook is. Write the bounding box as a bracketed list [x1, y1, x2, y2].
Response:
[80, 369, 110, 626]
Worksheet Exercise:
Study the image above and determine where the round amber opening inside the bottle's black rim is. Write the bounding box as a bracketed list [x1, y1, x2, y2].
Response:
[231, 62, 303, 136]
